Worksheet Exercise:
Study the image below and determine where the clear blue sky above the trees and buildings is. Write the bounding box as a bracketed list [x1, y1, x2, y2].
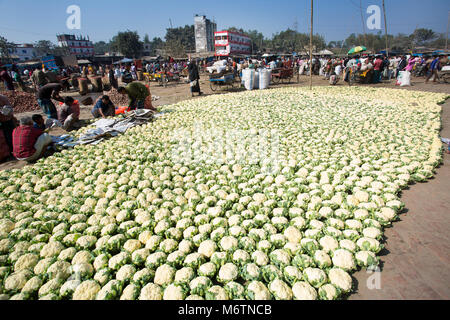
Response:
[0, 0, 450, 43]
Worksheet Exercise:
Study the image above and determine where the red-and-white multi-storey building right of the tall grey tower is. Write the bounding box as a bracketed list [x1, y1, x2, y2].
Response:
[214, 31, 252, 56]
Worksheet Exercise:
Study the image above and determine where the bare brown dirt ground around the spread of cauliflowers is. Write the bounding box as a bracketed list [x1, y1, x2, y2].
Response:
[0, 76, 450, 300]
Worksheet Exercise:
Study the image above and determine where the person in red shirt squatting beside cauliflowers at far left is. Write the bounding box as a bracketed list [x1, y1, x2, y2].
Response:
[13, 117, 52, 162]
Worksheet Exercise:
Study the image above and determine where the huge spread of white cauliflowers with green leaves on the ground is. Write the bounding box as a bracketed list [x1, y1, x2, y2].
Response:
[0, 87, 446, 300]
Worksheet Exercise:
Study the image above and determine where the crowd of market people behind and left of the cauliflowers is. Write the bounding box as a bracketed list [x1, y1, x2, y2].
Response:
[0, 54, 449, 162]
